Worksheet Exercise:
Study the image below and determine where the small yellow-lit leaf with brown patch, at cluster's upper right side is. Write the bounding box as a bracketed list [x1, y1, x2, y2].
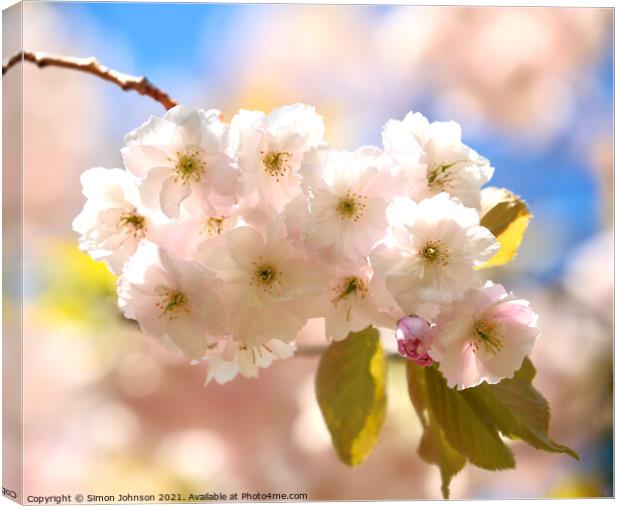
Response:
[479, 187, 532, 269]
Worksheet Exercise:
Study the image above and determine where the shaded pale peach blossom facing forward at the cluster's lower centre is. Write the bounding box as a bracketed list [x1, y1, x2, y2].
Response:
[205, 218, 326, 345]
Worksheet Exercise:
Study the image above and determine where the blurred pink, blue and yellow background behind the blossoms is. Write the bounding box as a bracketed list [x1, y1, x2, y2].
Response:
[4, 2, 613, 500]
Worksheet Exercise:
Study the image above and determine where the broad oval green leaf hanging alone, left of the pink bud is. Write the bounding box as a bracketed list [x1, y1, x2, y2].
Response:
[315, 327, 387, 466]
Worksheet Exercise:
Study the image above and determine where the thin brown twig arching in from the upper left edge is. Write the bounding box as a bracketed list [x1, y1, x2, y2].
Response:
[2, 51, 177, 109]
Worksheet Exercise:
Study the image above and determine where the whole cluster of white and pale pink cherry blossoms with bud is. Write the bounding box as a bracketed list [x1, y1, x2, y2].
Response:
[73, 104, 539, 389]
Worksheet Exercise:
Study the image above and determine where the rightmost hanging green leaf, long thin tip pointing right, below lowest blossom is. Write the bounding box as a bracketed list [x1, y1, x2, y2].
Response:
[462, 359, 579, 460]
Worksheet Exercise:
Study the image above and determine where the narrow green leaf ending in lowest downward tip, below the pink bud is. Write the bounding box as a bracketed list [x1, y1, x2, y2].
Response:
[407, 361, 467, 499]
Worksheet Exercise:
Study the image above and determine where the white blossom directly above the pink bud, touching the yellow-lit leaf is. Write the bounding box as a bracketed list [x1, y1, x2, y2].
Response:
[370, 193, 499, 315]
